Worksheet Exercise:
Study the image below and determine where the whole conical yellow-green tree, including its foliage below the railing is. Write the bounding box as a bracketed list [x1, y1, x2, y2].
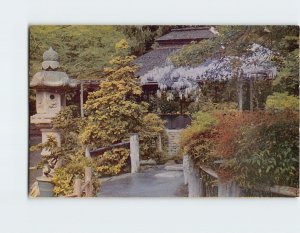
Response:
[80, 40, 164, 175]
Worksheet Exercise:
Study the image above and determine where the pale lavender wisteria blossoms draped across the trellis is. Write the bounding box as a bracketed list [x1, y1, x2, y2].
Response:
[140, 43, 277, 93]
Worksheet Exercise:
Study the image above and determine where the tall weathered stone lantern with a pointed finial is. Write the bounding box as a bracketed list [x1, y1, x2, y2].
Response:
[30, 47, 78, 196]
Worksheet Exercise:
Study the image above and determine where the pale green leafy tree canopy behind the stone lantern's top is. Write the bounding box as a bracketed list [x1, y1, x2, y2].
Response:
[29, 25, 125, 79]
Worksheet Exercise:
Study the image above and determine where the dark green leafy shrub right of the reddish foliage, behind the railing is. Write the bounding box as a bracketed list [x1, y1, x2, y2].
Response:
[224, 111, 299, 187]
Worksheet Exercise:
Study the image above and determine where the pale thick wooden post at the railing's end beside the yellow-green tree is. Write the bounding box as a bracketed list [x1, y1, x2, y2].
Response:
[130, 133, 140, 173]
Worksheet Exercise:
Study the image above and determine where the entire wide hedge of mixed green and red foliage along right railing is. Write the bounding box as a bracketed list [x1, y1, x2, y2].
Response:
[181, 109, 299, 187]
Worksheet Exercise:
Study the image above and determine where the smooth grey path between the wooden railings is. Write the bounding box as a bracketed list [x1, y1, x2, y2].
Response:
[97, 165, 187, 197]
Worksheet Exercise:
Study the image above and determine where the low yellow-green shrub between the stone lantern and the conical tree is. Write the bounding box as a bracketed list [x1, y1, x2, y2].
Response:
[30, 105, 99, 196]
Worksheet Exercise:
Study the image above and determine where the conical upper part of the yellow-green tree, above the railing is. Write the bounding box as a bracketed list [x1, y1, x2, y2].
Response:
[80, 39, 147, 147]
